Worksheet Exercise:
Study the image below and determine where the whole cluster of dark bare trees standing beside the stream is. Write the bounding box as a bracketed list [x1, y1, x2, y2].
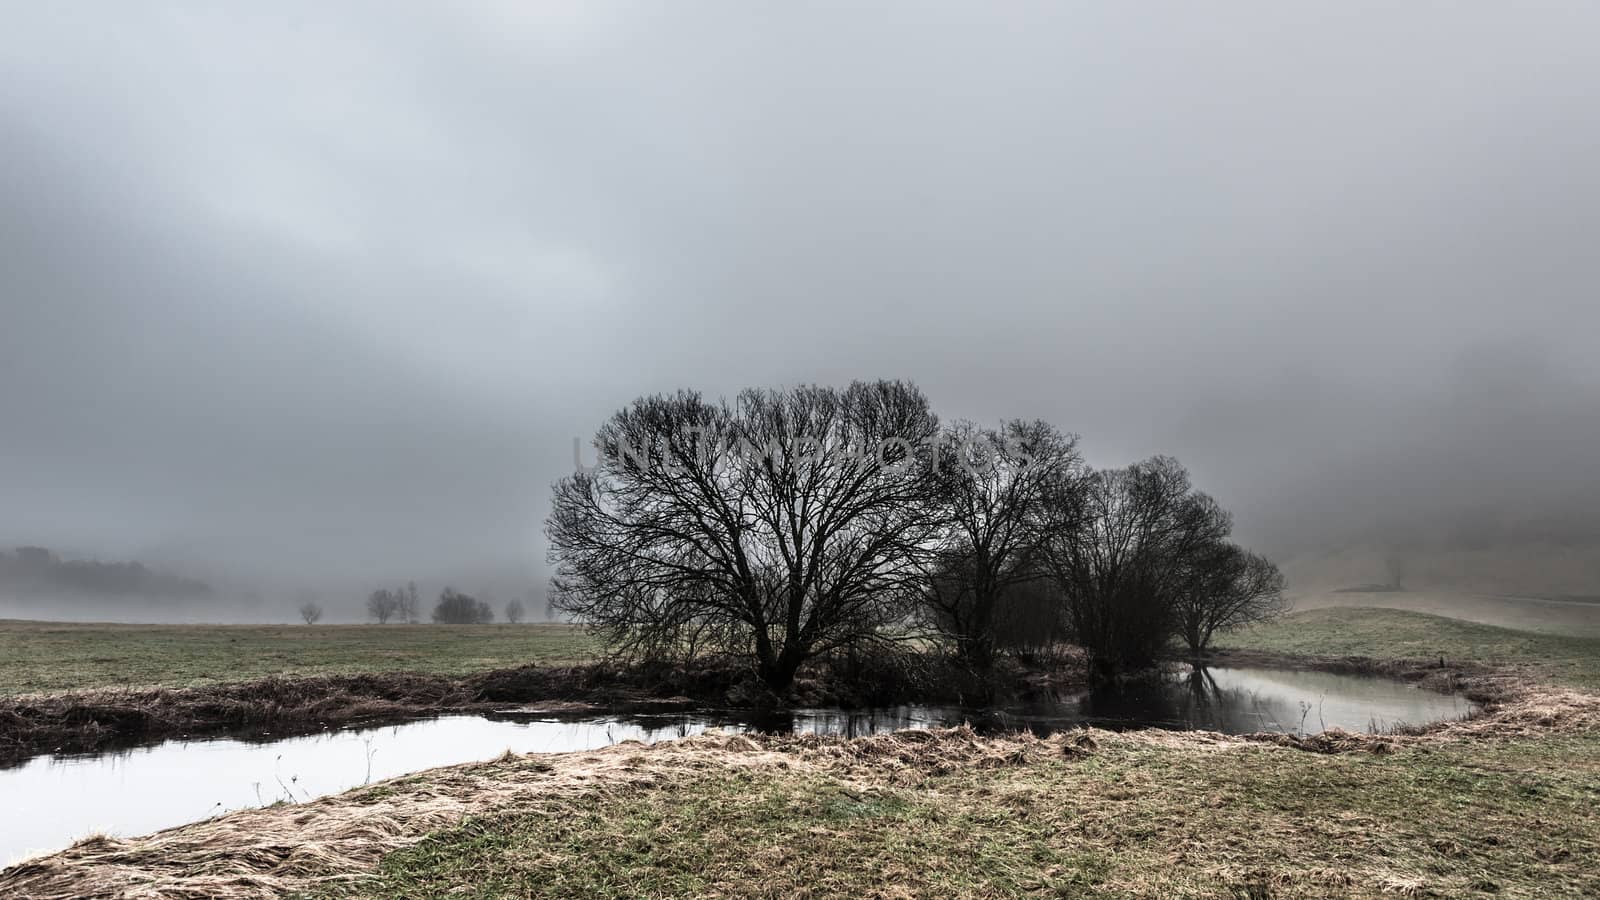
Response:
[547, 381, 1282, 690]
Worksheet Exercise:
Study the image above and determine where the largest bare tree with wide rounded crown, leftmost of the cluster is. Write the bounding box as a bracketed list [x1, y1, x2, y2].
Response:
[547, 381, 938, 692]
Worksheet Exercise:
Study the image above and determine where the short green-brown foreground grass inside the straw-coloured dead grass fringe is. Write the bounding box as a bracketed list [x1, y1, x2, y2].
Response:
[340, 732, 1600, 898]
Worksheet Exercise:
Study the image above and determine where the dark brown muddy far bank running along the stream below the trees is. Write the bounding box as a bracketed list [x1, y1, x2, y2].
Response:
[0, 650, 1074, 767]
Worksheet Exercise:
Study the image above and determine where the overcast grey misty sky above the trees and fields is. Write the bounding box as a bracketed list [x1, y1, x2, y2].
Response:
[0, 0, 1600, 592]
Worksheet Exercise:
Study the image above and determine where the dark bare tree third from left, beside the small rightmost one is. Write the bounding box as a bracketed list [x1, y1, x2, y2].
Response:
[1045, 456, 1230, 677]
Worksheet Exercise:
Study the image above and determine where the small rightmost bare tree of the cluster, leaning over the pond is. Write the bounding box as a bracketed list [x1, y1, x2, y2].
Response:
[1173, 541, 1285, 657]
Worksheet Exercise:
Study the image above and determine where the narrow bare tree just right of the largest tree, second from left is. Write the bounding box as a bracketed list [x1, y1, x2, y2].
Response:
[923, 421, 1085, 669]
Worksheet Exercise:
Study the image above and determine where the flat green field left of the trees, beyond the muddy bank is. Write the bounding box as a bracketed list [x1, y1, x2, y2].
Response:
[0, 620, 594, 695]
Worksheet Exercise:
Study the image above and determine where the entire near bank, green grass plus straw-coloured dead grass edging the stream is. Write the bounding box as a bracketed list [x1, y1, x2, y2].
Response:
[0, 672, 1600, 898]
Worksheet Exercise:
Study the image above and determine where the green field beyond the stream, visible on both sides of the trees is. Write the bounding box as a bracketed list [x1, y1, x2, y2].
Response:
[0, 607, 1600, 697]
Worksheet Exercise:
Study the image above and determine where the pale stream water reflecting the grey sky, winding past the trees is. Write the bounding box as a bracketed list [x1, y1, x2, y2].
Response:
[0, 669, 1472, 865]
